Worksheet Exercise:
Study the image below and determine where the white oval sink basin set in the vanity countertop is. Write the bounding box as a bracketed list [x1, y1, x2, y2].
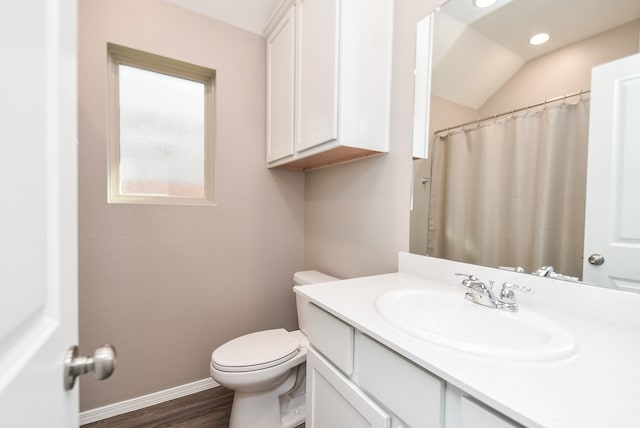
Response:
[376, 289, 577, 361]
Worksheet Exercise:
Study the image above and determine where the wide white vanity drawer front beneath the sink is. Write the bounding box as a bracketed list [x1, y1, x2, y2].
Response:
[355, 333, 444, 428]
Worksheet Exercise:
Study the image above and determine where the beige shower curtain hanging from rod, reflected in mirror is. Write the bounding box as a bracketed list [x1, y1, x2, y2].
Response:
[427, 97, 589, 277]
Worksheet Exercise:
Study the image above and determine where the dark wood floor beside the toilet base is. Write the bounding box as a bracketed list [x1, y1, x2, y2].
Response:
[82, 386, 304, 428]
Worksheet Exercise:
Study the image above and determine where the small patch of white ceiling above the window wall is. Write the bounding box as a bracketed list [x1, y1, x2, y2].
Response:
[163, 0, 280, 35]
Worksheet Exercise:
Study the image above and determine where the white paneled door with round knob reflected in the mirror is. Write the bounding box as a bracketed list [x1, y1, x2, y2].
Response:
[583, 54, 640, 291]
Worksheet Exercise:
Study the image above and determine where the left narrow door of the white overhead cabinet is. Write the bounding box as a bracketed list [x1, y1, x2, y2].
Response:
[267, 6, 295, 162]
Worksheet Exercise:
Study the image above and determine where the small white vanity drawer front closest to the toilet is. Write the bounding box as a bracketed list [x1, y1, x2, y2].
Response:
[307, 303, 354, 375]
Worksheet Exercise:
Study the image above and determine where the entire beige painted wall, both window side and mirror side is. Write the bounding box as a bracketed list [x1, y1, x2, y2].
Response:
[79, 0, 436, 410]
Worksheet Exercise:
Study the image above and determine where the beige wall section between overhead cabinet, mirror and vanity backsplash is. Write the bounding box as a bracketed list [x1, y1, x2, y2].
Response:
[304, 0, 437, 278]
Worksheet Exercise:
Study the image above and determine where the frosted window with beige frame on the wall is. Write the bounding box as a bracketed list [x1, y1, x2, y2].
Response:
[108, 44, 215, 205]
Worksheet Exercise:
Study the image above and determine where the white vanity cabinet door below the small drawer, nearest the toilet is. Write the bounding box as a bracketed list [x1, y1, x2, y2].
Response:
[306, 348, 391, 428]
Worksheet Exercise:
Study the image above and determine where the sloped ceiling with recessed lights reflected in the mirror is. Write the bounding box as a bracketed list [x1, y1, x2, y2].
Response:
[432, 0, 640, 108]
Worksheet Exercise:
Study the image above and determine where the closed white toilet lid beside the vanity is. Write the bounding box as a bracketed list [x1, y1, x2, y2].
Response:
[211, 328, 300, 372]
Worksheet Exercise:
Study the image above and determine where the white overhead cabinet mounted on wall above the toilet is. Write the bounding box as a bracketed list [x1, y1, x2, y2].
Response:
[266, 0, 393, 170]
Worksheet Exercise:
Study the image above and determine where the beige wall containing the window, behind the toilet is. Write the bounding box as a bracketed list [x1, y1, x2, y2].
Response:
[79, 0, 304, 410]
